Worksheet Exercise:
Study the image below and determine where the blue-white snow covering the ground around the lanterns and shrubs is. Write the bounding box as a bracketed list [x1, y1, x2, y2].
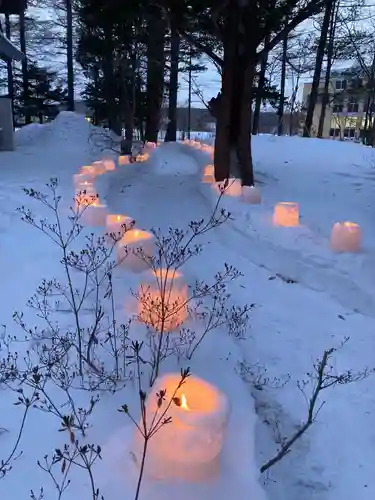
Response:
[0, 113, 375, 500]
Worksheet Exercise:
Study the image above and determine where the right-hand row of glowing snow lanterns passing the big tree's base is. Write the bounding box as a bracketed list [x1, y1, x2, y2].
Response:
[184, 141, 362, 253]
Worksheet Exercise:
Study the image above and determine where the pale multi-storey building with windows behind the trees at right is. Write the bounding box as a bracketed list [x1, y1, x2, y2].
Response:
[303, 68, 372, 140]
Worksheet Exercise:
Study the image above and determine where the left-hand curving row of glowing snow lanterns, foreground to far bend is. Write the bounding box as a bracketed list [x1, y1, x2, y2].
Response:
[74, 146, 229, 480]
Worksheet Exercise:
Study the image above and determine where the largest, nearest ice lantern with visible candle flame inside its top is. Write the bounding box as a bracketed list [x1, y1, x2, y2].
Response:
[133, 373, 229, 481]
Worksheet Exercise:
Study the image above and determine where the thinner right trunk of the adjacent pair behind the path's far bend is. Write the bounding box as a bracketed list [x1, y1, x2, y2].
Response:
[165, 21, 180, 141]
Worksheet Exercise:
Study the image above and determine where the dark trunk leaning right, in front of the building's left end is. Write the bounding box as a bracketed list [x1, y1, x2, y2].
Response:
[303, 0, 334, 137]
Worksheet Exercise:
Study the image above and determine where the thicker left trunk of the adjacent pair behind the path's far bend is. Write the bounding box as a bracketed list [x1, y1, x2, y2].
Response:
[145, 6, 165, 142]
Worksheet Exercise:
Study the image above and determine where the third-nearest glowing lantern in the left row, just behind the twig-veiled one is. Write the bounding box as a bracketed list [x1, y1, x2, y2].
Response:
[116, 229, 155, 272]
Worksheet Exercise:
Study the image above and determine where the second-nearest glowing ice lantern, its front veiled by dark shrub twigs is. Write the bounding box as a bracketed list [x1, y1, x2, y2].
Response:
[138, 269, 188, 332]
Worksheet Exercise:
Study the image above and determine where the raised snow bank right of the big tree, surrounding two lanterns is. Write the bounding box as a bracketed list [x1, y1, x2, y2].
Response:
[189, 135, 375, 317]
